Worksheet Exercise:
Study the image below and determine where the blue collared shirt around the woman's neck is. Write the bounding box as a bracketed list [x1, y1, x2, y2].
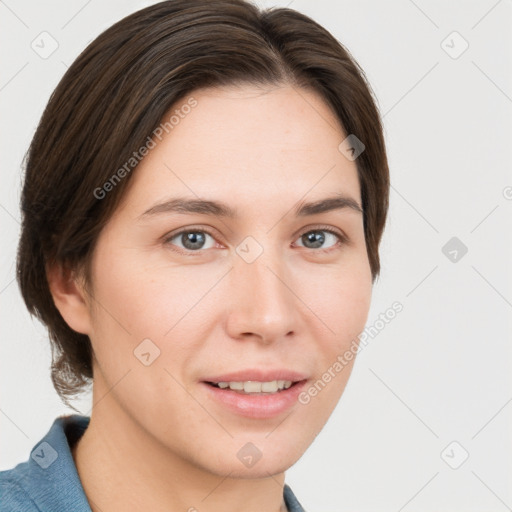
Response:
[0, 414, 305, 512]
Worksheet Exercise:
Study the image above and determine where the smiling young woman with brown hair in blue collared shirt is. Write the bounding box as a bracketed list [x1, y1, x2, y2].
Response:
[0, 0, 389, 512]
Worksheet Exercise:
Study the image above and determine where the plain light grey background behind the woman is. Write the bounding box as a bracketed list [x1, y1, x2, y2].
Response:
[0, 0, 512, 512]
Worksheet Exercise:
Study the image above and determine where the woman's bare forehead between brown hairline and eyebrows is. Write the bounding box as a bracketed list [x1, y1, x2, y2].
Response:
[119, 85, 360, 216]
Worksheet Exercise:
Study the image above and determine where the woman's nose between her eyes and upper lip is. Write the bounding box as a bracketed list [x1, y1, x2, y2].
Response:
[227, 243, 300, 344]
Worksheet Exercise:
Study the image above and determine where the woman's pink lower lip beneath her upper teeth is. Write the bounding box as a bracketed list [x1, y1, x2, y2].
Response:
[201, 380, 307, 419]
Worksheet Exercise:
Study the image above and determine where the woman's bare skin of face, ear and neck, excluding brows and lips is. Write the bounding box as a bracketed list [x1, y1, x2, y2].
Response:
[49, 85, 372, 512]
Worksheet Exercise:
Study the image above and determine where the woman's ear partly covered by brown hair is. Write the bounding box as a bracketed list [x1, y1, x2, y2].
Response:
[46, 263, 92, 334]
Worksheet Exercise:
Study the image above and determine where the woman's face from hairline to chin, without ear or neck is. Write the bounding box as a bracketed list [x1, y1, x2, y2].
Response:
[86, 86, 372, 478]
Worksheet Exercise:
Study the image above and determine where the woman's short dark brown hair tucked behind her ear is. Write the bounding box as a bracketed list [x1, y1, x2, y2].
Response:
[17, 0, 389, 405]
